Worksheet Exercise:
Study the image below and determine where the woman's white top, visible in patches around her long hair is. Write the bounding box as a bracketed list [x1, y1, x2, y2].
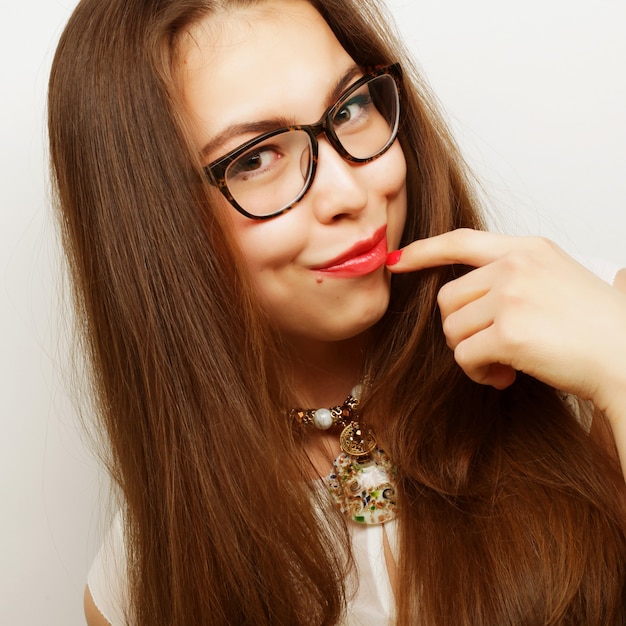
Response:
[87, 259, 620, 626]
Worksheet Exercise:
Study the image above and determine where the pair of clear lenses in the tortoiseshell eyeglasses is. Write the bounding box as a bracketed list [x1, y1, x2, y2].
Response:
[226, 74, 398, 217]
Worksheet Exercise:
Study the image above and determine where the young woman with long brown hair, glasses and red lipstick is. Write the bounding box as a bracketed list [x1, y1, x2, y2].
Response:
[49, 0, 626, 626]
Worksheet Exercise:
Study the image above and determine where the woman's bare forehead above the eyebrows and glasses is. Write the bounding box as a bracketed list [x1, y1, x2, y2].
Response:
[183, 0, 354, 155]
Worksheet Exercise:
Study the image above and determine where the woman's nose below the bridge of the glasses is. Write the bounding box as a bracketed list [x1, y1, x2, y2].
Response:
[309, 137, 368, 223]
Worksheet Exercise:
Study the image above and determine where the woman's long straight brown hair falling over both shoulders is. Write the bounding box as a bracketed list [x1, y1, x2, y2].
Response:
[49, 0, 626, 626]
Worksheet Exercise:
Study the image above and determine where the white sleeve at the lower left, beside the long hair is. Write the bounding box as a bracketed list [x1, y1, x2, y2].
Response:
[87, 514, 128, 626]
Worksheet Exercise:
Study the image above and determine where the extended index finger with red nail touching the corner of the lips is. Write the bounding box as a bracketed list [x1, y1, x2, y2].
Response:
[387, 228, 512, 273]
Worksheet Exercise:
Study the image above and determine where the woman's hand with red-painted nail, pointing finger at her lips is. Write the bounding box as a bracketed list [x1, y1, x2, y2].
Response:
[388, 229, 626, 426]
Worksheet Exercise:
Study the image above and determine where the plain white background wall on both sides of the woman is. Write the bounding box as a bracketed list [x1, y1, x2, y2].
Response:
[0, 0, 626, 626]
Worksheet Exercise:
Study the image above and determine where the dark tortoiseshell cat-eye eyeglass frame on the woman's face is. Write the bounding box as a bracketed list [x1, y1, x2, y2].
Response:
[204, 63, 402, 220]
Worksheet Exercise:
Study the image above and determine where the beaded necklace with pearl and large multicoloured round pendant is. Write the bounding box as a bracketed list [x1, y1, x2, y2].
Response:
[289, 385, 396, 524]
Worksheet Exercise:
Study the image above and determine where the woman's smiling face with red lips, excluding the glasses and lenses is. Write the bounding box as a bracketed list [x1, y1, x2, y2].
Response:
[184, 0, 406, 341]
